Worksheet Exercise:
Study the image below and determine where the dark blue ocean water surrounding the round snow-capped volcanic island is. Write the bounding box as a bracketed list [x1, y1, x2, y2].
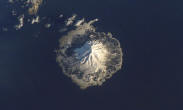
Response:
[0, 0, 183, 110]
